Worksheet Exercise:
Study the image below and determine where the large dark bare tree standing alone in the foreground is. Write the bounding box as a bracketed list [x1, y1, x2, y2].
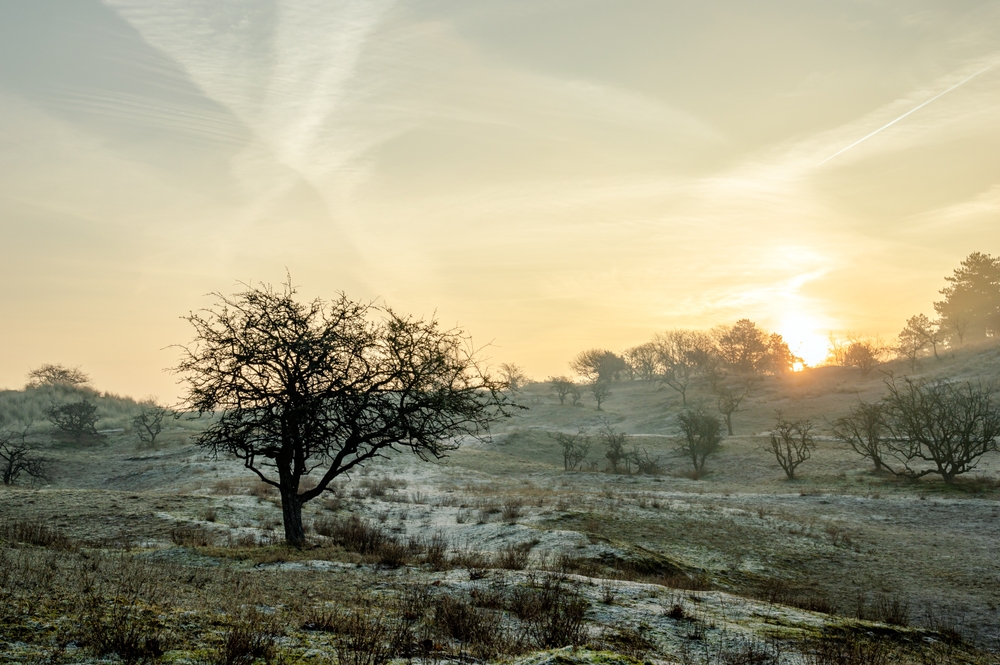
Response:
[175, 280, 513, 547]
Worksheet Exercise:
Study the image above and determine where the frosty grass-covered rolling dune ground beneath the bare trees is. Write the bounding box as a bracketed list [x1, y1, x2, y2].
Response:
[0, 347, 1000, 665]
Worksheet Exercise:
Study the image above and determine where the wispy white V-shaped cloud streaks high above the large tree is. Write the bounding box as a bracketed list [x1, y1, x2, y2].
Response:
[108, 0, 391, 199]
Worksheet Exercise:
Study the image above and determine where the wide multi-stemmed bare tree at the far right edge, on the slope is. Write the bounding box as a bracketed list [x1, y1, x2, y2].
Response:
[883, 377, 1000, 484]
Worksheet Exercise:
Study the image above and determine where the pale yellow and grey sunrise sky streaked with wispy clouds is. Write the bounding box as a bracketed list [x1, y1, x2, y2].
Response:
[0, 0, 1000, 402]
